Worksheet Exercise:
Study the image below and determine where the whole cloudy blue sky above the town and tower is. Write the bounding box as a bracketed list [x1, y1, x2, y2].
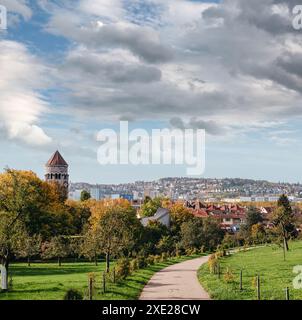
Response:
[0, 0, 302, 184]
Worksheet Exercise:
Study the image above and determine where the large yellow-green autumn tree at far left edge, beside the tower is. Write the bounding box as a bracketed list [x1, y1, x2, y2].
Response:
[0, 169, 52, 290]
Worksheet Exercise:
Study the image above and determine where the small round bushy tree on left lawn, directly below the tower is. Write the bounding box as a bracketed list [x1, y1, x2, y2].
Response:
[42, 236, 70, 266]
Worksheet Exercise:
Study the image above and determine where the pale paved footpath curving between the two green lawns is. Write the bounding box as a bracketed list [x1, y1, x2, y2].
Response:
[140, 257, 210, 300]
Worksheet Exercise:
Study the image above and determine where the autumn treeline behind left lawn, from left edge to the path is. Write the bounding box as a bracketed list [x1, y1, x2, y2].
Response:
[0, 169, 224, 290]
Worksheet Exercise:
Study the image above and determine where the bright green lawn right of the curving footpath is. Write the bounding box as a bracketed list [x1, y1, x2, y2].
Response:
[198, 241, 302, 300]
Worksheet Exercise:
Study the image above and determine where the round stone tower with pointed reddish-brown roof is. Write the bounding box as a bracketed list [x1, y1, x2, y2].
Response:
[45, 151, 69, 191]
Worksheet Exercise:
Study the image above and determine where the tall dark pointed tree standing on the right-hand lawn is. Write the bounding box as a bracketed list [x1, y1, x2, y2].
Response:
[272, 194, 295, 251]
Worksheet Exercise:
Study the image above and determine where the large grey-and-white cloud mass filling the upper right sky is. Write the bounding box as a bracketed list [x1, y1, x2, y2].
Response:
[35, 0, 302, 139]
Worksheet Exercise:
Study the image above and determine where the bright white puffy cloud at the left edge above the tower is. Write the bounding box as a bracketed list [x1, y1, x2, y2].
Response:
[0, 40, 51, 145]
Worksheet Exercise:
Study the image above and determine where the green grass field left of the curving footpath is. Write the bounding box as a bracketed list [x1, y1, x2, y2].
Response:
[0, 257, 198, 300]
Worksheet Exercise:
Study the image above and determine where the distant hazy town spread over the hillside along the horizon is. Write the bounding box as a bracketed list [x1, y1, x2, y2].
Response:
[69, 178, 302, 203]
